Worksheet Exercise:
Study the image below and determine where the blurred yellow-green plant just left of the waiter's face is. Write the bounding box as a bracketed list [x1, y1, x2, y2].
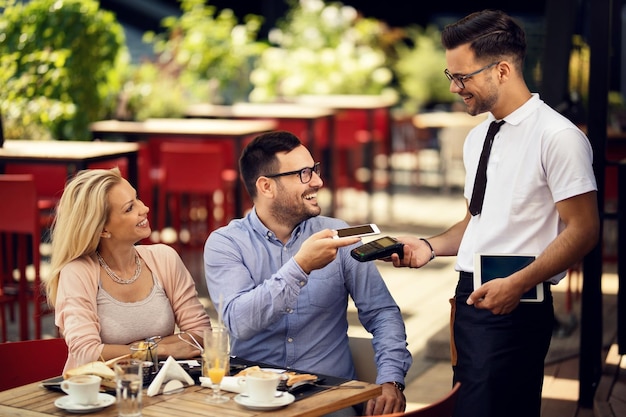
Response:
[394, 26, 456, 113]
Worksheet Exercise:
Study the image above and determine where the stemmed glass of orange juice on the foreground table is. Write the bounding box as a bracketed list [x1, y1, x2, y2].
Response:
[203, 327, 230, 404]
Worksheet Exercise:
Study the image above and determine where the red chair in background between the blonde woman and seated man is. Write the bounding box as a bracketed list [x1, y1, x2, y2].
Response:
[157, 141, 237, 246]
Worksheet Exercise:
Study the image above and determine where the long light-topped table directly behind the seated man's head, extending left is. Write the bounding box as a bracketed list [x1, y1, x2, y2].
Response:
[89, 119, 276, 217]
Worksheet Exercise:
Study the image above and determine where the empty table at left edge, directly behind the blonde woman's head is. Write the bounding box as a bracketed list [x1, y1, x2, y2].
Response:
[0, 140, 139, 184]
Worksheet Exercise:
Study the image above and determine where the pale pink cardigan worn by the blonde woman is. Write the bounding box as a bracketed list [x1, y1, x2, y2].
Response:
[55, 244, 211, 371]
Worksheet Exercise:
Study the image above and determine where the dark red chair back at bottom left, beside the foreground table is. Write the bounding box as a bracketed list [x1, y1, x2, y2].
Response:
[0, 338, 67, 391]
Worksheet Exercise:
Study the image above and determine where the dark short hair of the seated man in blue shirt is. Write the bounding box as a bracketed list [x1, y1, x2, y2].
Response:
[239, 130, 302, 198]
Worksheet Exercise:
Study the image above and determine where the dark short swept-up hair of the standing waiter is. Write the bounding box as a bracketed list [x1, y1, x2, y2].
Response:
[441, 10, 526, 72]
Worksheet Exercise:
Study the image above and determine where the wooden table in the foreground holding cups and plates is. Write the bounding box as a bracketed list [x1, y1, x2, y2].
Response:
[0, 381, 382, 417]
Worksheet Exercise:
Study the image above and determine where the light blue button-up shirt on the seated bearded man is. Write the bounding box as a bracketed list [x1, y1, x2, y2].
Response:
[204, 210, 412, 384]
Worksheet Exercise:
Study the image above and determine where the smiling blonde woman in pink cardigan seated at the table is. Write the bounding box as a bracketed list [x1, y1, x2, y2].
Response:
[45, 168, 211, 370]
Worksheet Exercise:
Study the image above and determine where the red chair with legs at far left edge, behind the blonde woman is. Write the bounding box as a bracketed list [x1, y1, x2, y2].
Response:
[0, 174, 50, 340]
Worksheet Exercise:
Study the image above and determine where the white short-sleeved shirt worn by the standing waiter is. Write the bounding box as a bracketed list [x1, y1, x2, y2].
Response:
[455, 94, 597, 283]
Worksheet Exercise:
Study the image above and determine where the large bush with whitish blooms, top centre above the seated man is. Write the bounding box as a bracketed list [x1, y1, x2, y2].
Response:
[250, 0, 395, 102]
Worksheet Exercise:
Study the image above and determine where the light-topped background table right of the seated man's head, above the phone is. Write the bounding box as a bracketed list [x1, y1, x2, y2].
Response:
[291, 94, 398, 220]
